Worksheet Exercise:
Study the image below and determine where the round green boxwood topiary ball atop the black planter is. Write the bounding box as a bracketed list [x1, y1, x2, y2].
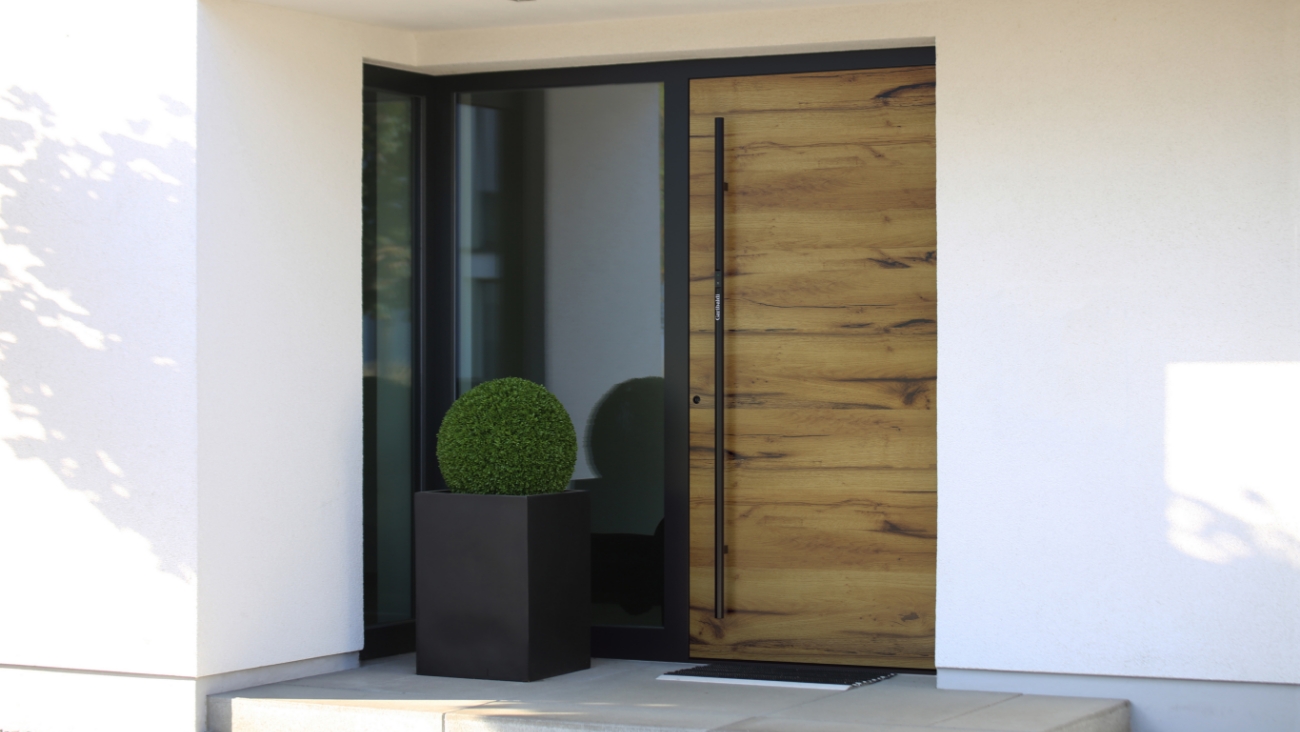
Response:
[438, 377, 577, 495]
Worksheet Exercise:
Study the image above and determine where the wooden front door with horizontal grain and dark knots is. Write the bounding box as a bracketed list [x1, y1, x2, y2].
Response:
[690, 66, 937, 668]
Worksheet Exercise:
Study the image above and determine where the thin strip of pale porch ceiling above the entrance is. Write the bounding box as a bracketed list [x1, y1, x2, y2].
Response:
[245, 0, 915, 30]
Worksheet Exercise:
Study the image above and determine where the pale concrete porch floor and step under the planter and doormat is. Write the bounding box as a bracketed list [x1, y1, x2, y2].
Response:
[208, 654, 1128, 732]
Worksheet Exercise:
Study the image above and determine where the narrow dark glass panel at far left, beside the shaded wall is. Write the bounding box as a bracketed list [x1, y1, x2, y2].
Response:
[361, 90, 416, 627]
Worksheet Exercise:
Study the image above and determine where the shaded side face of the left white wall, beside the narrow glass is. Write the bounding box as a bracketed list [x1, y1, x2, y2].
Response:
[198, 0, 412, 673]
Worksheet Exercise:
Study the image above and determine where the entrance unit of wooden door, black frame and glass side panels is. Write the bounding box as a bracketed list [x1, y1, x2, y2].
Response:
[363, 47, 935, 667]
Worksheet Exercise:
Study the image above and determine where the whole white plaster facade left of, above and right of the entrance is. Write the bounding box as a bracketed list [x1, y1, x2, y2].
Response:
[0, 0, 1300, 732]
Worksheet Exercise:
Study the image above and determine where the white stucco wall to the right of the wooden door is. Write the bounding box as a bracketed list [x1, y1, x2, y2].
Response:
[937, 0, 1300, 684]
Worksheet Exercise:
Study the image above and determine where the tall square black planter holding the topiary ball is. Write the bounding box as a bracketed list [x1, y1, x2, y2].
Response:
[415, 490, 592, 681]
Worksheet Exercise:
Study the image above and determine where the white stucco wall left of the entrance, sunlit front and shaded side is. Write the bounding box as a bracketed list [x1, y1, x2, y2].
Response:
[0, 0, 413, 732]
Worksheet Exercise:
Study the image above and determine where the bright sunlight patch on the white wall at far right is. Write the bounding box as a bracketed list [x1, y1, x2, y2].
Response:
[1165, 363, 1300, 568]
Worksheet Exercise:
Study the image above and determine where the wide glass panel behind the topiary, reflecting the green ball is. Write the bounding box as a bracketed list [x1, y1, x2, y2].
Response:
[456, 85, 663, 625]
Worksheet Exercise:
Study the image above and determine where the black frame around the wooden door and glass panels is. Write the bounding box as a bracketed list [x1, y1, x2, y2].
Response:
[361, 47, 935, 660]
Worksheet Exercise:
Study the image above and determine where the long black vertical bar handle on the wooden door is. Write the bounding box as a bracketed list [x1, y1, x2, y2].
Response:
[714, 117, 727, 619]
